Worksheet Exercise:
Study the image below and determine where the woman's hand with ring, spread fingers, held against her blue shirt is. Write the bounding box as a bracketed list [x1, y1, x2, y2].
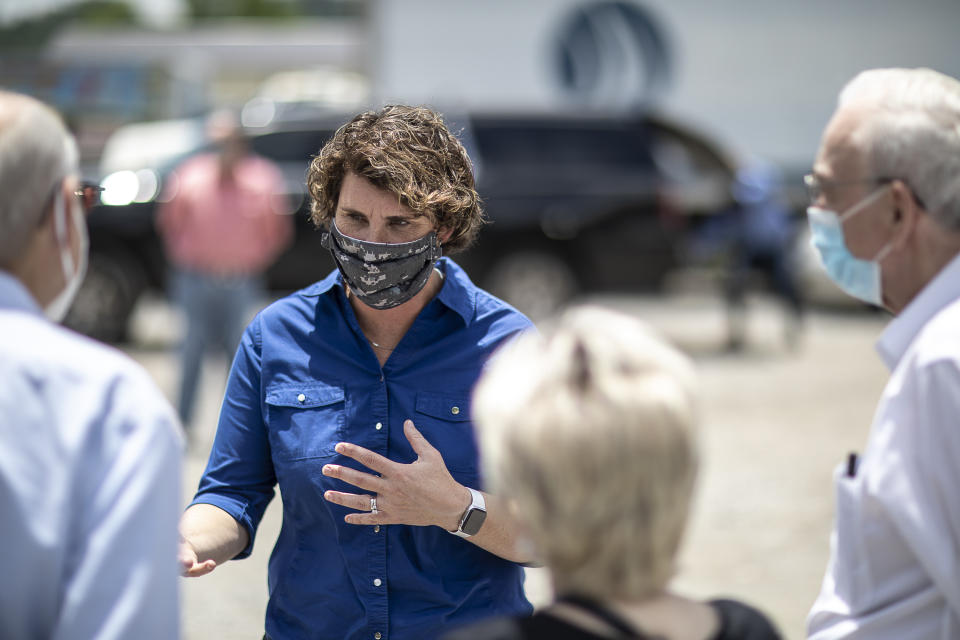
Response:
[323, 420, 471, 531]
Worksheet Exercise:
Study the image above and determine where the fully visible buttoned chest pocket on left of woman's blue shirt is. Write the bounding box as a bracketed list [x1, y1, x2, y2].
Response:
[266, 381, 345, 460]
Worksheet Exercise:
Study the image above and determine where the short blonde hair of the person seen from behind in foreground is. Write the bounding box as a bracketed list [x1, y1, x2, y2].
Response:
[474, 307, 697, 599]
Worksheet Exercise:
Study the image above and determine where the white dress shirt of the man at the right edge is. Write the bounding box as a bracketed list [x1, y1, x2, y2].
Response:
[807, 256, 960, 640]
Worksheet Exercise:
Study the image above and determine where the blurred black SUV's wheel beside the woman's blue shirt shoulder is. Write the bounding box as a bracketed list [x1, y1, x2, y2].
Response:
[485, 251, 579, 321]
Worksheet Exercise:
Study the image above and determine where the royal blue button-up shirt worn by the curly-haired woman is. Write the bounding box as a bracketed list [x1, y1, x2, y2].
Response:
[188, 258, 531, 640]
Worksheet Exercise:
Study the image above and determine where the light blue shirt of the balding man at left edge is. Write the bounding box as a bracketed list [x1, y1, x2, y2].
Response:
[0, 271, 183, 640]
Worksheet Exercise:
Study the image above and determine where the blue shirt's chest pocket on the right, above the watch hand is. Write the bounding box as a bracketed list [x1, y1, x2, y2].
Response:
[413, 392, 477, 478]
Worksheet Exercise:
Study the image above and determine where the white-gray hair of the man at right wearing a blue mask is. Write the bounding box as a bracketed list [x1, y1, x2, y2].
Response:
[839, 69, 960, 230]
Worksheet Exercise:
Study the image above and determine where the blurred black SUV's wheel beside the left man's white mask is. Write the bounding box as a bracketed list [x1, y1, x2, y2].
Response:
[64, 253, 144, 342]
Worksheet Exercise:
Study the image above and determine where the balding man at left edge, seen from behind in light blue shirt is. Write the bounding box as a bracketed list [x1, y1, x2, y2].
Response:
[0, 91, 183, 640]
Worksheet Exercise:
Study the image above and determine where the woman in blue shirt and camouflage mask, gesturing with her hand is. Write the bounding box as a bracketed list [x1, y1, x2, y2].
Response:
[181, 105, 532, 640]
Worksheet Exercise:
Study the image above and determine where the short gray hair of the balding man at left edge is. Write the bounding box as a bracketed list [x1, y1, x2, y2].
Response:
[0, 90, 78, 268]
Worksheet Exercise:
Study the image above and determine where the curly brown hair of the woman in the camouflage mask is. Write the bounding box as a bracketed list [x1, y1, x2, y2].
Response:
[307, 105, 486, 254]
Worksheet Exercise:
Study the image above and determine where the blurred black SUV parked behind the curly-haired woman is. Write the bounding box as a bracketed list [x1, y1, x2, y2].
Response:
[67, 114, 733, 341]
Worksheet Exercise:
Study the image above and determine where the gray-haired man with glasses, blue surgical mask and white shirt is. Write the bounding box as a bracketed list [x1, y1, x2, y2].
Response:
[806, 69, 960, 639]
